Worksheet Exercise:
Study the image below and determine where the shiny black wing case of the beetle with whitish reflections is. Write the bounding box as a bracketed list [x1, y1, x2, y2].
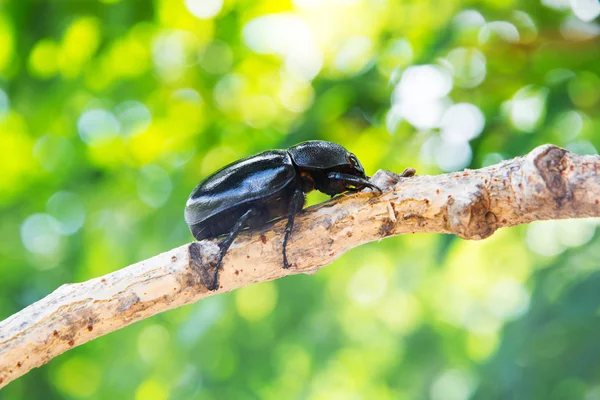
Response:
[185, 150, 296, 225]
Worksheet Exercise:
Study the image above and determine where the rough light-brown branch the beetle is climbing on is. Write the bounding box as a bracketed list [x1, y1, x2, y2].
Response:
[0, 145, 600, 388]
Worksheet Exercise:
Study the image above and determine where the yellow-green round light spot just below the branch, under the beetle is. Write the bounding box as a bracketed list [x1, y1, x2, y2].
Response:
[235, 282, 277, 322]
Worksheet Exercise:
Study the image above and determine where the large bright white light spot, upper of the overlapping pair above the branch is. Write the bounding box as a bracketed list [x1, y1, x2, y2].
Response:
[394, 65, 452, 102]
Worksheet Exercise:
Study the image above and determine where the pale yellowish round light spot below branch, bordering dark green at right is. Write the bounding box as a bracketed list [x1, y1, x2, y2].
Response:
[488, 278, 529, 320]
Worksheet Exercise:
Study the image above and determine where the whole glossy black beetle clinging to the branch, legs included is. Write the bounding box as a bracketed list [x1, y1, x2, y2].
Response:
[185, 140, 381, 290]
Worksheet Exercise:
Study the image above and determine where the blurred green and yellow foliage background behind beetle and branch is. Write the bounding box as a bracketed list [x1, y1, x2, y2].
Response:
[0, 0, 600, 400]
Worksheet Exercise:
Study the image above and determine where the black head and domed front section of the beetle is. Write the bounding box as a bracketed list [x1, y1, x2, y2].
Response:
[288, 140, 368, 196]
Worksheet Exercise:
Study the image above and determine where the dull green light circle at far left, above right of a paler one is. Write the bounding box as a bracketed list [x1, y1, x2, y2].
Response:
[46, 192, 85, 235]
